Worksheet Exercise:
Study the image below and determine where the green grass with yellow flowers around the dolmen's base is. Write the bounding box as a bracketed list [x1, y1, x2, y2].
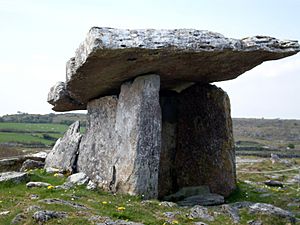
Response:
[0, 157, 300, 225]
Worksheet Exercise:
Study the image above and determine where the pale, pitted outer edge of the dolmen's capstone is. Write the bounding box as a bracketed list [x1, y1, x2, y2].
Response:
[66, 27, 300, 82]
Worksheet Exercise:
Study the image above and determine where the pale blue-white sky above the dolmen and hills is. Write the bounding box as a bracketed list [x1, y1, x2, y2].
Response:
[0, 0, 300, 119]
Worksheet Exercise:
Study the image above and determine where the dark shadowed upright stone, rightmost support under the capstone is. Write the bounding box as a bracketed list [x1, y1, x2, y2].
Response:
[176, 84, 236, 196]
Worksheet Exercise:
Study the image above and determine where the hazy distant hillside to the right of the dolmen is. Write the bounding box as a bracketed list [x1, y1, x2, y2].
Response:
[233, 118, 300, 157]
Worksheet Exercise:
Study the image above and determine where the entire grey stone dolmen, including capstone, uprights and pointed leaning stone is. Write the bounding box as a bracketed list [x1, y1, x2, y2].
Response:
[46, 27, 300, 199]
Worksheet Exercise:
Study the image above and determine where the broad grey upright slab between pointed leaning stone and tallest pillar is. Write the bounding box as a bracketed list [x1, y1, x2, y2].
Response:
[77, 96, 118, 190]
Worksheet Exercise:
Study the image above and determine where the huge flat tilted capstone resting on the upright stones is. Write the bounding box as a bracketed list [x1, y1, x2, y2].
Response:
[48, 27, 300, 111]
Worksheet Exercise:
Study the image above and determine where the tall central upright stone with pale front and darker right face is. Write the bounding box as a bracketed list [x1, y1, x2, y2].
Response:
[115, 75, 161, 198]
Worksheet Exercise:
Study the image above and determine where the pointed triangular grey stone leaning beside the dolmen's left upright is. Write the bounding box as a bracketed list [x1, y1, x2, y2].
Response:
[45, 121, 82, 173]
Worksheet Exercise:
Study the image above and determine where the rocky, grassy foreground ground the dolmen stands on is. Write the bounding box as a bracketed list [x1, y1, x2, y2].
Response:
[0, 154, 300, 225]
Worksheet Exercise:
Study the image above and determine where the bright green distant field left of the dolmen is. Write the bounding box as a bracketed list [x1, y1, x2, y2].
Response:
[0, 122, 68, 147]
